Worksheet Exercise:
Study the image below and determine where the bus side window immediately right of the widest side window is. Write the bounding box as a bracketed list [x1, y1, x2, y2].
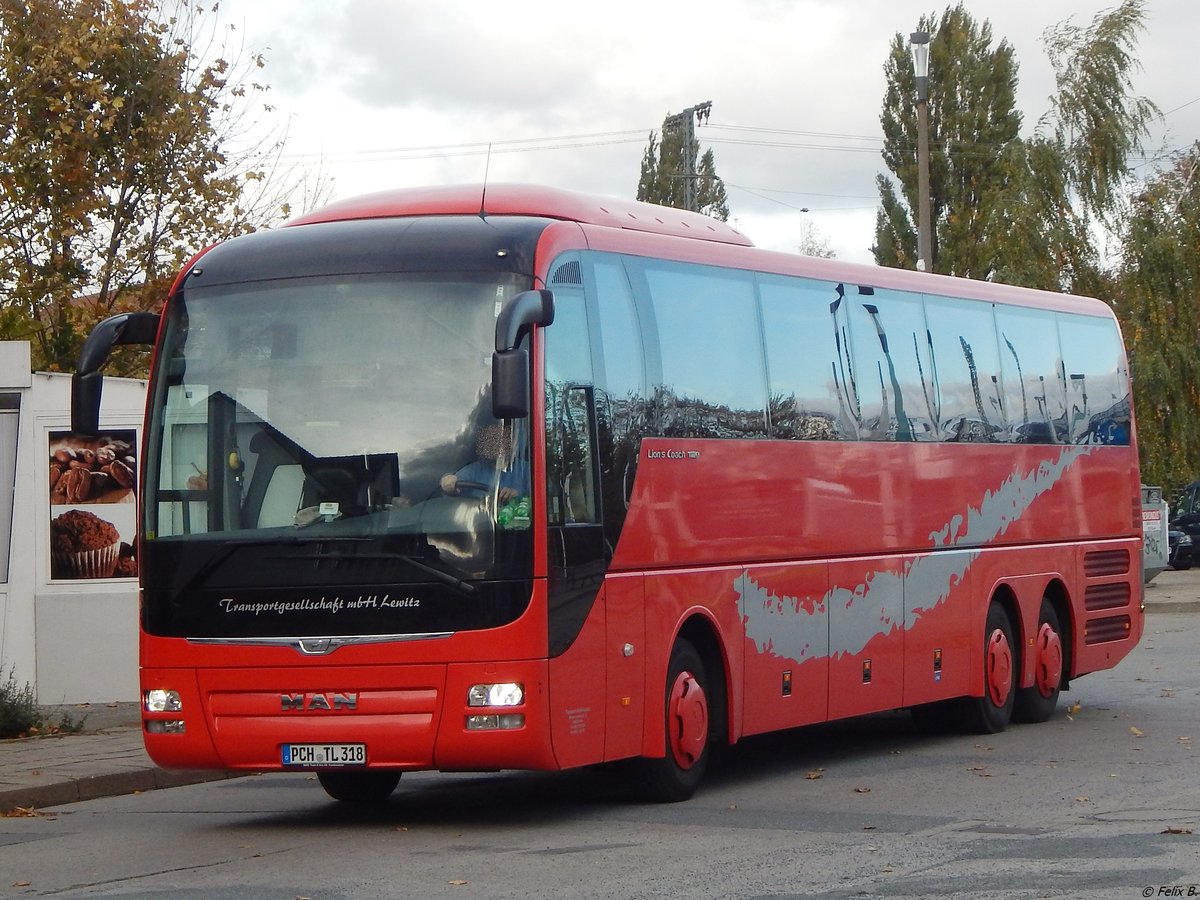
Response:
[758, 276, 857, 440]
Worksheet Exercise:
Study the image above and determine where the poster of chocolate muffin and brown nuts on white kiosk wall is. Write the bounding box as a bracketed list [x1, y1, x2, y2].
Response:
[49, 430, 138, 581]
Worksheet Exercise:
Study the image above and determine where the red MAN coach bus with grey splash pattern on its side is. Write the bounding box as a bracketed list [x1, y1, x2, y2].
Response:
[74, 185, 1142, 800]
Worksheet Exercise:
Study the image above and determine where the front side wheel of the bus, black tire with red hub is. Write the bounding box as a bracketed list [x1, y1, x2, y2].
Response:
[637, 638, 712, 803]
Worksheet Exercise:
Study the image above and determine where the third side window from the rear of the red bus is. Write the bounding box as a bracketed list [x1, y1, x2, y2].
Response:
[925, 296, 1008, 442]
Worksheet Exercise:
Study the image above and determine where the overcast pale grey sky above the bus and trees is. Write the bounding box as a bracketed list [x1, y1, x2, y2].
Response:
[220, 0, 1200, 262]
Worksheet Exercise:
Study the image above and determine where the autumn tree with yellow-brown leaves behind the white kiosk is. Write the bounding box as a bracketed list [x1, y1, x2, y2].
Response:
[0, 0, 309, 371]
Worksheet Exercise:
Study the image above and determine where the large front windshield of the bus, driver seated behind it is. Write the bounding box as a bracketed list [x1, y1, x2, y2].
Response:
[143, 272, 529, 638]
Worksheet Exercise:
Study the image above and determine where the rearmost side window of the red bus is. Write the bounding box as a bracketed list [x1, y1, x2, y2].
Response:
[1058, 314, 1129, 444]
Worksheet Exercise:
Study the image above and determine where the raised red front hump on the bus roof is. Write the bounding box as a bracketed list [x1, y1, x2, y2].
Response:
[288, 184, 752, 247]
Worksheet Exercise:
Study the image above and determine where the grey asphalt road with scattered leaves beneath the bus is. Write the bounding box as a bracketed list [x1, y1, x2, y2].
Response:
[0, 613, 1200, 900]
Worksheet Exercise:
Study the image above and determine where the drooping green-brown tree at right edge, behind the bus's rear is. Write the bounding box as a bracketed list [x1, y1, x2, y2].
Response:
[1117, 143, 1200, 498]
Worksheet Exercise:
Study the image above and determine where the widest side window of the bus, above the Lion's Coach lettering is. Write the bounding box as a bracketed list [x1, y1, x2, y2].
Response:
[632, 260, 767, 438]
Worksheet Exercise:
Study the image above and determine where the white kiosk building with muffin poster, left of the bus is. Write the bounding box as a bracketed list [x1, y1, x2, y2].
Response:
[0, 341, 146, 704]
